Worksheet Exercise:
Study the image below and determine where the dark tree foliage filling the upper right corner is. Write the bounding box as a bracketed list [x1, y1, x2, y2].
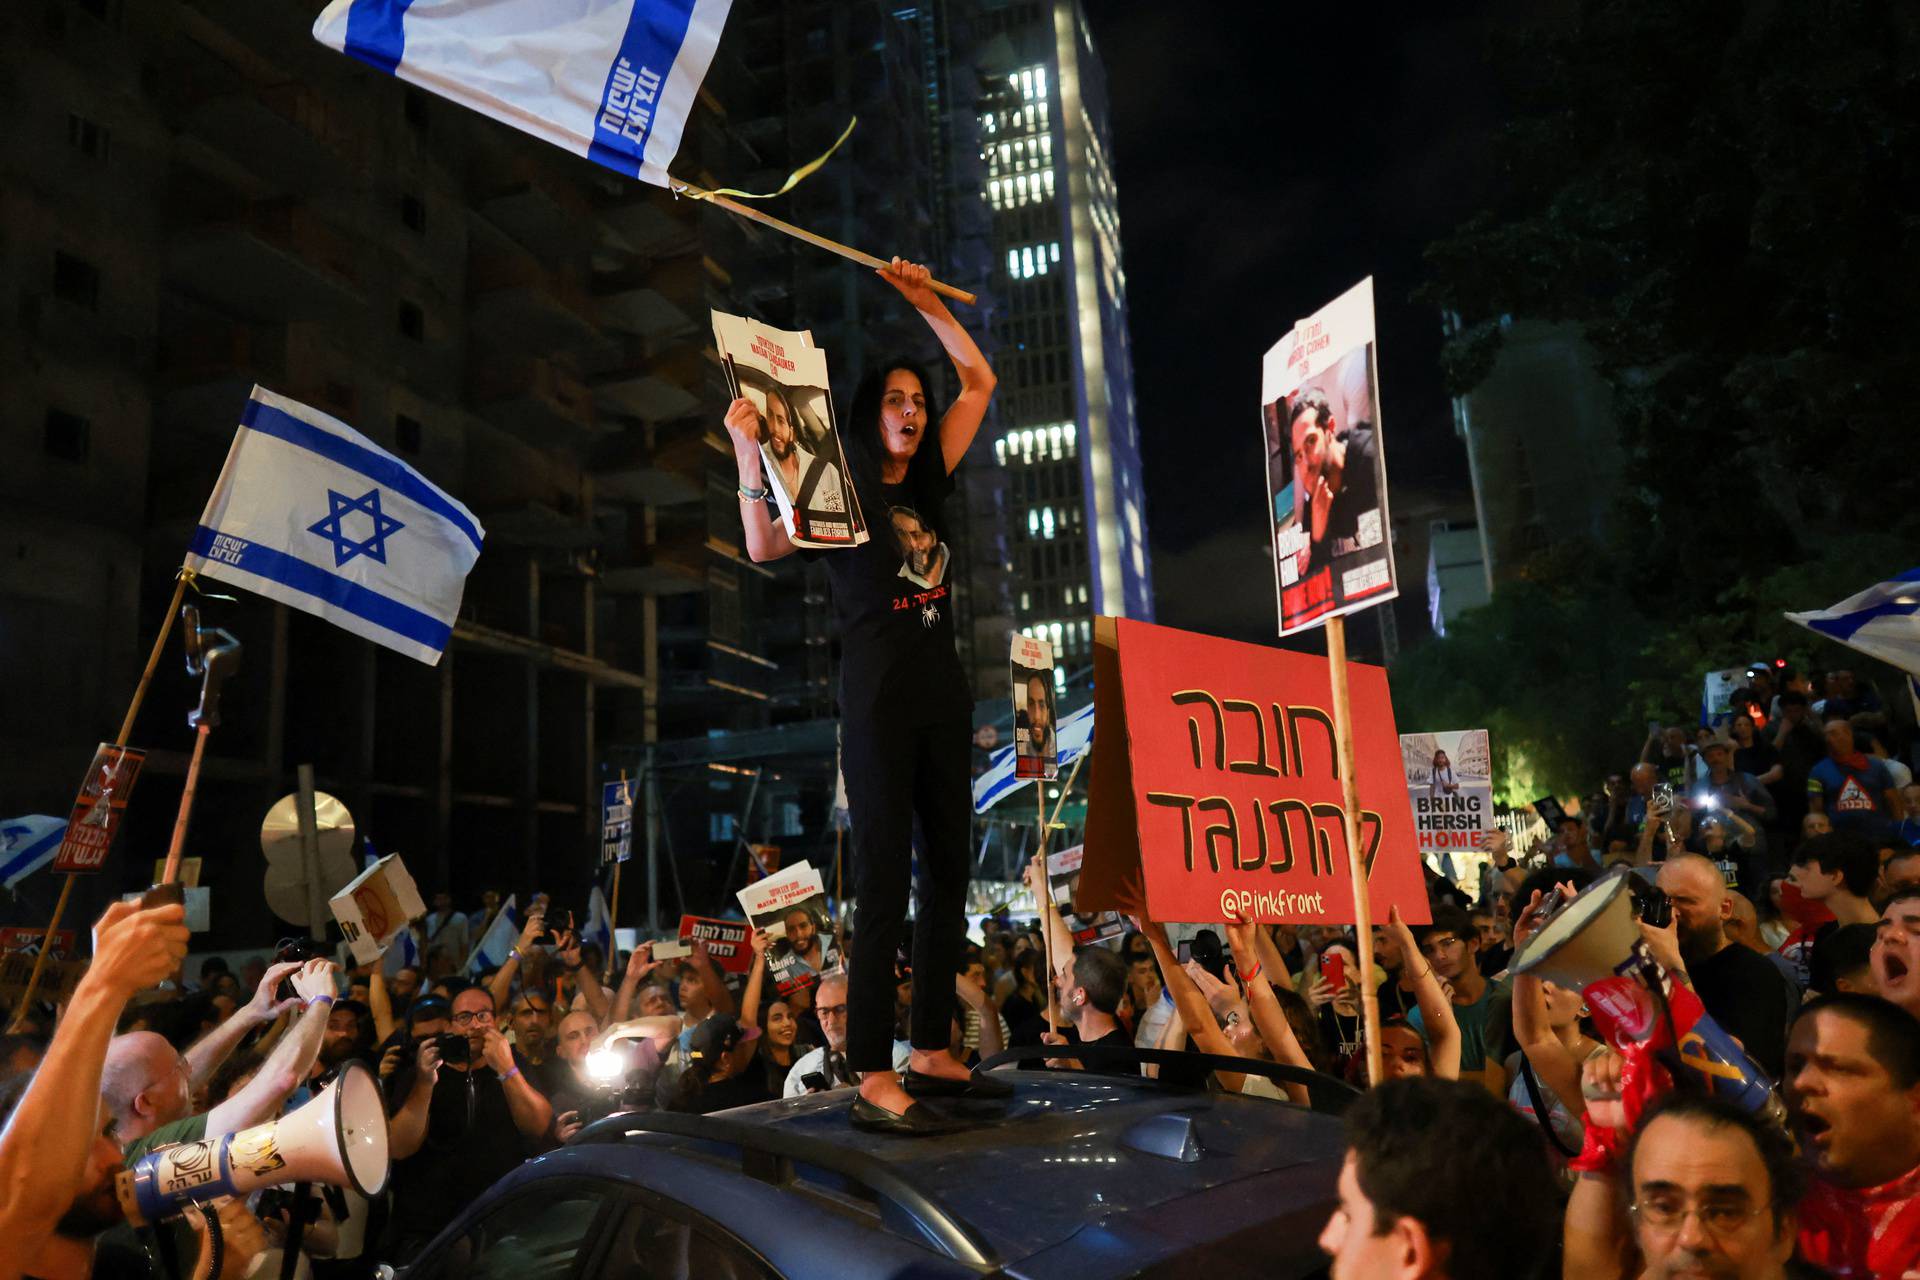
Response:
[1394, 0, 1920, 794]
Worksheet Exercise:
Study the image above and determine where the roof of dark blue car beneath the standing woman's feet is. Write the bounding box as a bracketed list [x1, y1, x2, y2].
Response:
[576, 1071, 1346, 1263]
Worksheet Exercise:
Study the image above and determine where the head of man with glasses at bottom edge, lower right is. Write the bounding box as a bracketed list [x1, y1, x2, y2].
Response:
[1626, 1094, 1797, 1280]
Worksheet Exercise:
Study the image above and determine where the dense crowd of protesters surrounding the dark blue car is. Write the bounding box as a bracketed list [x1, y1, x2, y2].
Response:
[11, 670, 1920, 1280]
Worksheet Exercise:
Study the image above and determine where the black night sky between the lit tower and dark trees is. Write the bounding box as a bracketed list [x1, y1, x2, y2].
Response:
[1089, 0, 1494, 643]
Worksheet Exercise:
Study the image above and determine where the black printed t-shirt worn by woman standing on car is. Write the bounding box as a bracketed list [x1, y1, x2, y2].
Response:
[820, 449, 972, 725]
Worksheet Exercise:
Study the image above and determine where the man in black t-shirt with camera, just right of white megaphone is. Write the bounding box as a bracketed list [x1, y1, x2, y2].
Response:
[380, 986, 553, 1263]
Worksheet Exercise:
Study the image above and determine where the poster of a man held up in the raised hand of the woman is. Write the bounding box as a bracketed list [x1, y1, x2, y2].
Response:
[712, 311, 868, 547]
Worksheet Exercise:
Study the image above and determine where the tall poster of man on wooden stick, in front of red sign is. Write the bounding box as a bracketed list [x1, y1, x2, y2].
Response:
[1260, 276, 1400, 635]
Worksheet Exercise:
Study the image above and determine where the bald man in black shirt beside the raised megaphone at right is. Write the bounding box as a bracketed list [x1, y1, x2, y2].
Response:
[1640, 854, 1799, 1080]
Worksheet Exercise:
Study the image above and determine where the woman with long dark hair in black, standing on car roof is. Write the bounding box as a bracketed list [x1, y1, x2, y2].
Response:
[726, 259, 1008, 1134]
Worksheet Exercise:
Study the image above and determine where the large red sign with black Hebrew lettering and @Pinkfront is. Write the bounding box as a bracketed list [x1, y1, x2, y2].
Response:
[1075, 618, 1428, 925]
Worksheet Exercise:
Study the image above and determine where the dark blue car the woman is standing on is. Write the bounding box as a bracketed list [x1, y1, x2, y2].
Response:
[401, 1054, 1344, 1280]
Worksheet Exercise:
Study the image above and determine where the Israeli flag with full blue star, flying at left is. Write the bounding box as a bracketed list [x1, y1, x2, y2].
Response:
[186, 388, 486, 664]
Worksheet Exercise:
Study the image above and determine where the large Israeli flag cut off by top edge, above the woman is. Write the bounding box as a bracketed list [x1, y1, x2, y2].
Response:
[313, 0, 730, 186]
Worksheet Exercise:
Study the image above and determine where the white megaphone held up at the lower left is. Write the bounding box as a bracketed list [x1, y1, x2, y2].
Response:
[117, 1063, 388, 1226]
